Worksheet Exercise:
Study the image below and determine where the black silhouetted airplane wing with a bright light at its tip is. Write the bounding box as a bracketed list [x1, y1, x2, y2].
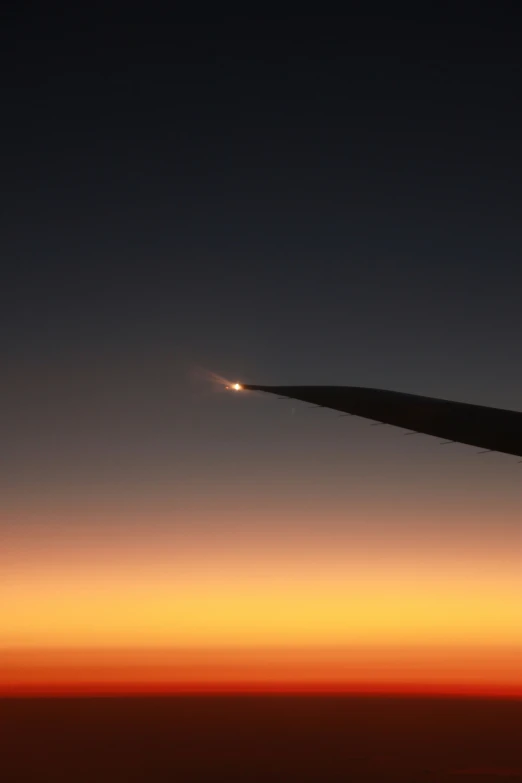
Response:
[243, 384, 522, 457]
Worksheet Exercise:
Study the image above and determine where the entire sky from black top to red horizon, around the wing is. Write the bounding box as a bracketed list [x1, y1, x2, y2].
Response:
[0, 3, 522, 695]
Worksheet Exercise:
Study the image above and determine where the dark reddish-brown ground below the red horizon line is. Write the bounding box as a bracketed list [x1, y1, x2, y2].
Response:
[0, 696, 522, 783]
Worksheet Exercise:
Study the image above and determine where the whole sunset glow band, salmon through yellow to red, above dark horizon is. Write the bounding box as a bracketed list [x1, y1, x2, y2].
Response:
[0, 502, 522, 698]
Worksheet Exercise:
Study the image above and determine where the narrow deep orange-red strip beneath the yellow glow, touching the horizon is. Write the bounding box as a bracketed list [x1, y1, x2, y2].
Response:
[4, 647, 522, 698]
